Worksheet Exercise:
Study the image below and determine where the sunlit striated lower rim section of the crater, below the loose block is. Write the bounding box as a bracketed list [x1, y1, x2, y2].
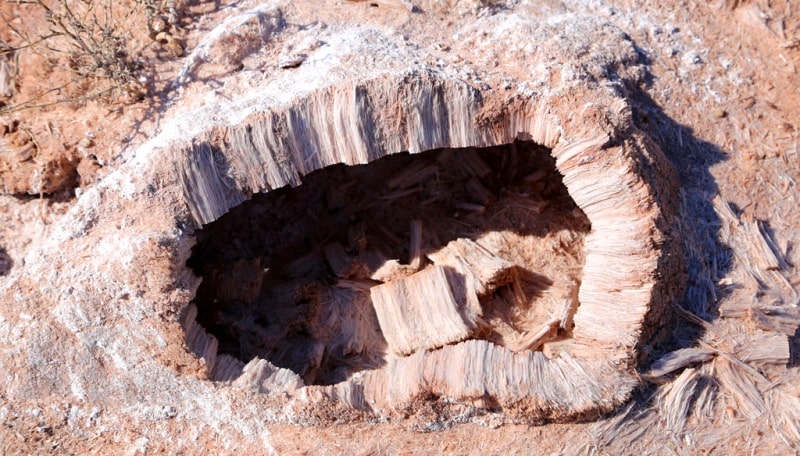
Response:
[354, 339, 636, 421]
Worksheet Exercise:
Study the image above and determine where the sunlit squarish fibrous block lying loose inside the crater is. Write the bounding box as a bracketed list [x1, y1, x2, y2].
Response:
[370, 266, 478, 355]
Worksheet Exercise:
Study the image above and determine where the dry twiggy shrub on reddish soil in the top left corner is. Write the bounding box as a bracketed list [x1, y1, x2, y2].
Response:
[0, 0, 177, 114]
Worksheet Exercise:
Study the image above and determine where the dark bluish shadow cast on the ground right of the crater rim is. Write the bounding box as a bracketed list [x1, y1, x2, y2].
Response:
[598, 44, 733, 430]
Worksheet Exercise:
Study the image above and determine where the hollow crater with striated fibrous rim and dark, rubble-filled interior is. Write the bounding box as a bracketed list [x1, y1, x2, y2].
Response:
[170, 72, 682, 422]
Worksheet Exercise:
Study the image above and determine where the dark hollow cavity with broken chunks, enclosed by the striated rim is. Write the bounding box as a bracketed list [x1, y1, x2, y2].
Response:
[188, 142, 589, 385]
